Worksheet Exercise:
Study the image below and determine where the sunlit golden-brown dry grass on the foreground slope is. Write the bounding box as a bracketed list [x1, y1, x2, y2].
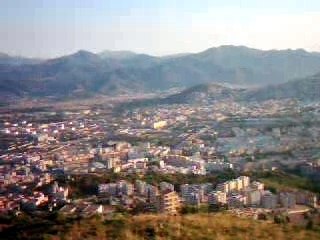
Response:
[53, 213, 320, 240]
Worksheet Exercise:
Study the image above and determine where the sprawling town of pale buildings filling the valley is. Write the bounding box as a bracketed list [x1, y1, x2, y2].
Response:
[0, 97, 320, 225]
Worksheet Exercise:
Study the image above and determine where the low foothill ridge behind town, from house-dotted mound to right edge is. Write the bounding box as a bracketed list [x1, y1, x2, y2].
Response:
[120, 73, 320, 109]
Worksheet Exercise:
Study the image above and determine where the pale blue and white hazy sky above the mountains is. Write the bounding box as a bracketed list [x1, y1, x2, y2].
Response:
[0, 0, 320, 58]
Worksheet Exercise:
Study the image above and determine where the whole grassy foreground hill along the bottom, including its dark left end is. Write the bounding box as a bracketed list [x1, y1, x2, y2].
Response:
[2, 213, 320, 240]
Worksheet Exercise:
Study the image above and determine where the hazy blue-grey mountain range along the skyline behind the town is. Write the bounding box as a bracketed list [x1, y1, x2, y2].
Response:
[0, 46, 320, 99]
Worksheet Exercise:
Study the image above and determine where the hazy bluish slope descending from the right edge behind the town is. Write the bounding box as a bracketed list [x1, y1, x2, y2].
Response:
[242, 73, 320, 101]
